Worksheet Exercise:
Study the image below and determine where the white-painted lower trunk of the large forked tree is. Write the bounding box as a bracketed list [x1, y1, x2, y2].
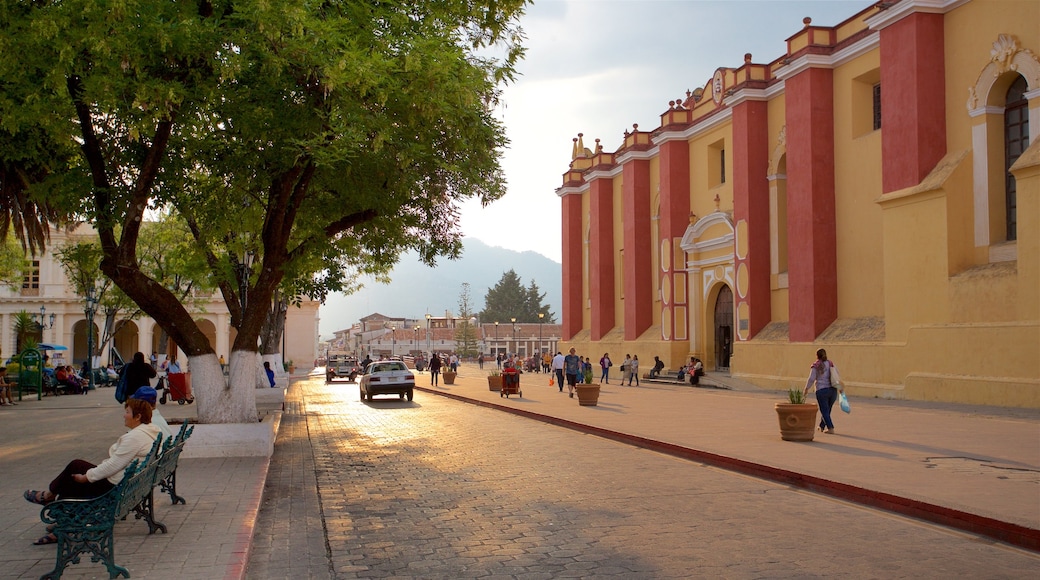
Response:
[188, 350, 267, 423]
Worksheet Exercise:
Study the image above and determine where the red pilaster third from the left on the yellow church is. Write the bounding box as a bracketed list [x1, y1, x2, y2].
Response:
[622, 159, 653, 340]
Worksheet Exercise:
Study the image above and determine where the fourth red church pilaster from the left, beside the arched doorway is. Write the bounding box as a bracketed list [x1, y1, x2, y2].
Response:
[658, 139, 690, 341]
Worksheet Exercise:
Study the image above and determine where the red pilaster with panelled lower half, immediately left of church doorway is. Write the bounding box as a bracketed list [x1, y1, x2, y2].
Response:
[657, 138, 690, 341]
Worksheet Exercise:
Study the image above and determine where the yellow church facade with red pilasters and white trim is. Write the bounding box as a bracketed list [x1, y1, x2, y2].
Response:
[556, 0, 1040, 407]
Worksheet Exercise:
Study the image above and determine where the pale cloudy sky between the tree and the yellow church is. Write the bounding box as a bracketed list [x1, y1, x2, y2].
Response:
[461, 0, 873, 262]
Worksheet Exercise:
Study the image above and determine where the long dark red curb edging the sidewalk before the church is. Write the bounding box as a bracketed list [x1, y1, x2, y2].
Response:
[415, 385, 1040, 552]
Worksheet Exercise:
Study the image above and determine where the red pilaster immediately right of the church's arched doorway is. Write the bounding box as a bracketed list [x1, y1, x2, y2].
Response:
[733, 101, 772, 339]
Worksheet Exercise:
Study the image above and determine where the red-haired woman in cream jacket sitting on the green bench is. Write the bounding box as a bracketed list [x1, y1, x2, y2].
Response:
[23, 393, 159, 546]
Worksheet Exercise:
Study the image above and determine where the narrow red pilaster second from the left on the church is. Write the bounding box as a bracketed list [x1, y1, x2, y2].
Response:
[589, 177, 615, 341]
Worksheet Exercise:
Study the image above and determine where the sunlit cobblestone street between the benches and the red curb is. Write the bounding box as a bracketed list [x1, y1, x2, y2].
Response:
[248, 379, 1038, 579]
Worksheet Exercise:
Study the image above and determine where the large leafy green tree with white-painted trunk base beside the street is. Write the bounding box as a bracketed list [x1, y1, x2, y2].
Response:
[0, 0, 525, 423]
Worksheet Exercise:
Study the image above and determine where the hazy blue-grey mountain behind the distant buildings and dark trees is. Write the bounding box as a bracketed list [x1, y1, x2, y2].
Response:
[318, 238, 563, 338]
